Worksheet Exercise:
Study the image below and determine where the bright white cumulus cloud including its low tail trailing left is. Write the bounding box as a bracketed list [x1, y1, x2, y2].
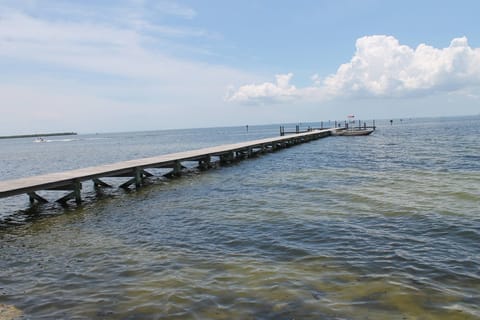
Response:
[229, 35, 480, 102]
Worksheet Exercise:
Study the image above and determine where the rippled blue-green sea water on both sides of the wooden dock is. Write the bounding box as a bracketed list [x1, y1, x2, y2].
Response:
[0, 117, 480, 319]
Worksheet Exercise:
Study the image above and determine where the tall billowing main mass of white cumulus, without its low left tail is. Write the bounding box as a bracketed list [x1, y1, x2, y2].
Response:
[325, 36, 480, 96]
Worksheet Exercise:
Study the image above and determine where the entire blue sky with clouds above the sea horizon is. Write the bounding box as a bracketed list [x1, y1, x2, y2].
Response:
[0, 0, 480, 135]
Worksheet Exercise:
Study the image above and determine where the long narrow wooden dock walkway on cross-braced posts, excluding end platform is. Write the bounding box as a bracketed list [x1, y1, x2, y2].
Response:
[0, 128, 336, 204]
